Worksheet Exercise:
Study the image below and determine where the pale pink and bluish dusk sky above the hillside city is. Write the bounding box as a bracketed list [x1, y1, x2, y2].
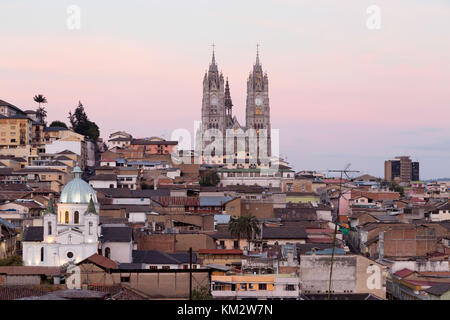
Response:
[0, 1, 450, 179]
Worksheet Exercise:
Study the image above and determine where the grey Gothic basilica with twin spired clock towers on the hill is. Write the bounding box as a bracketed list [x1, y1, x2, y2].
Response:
[199, 51, 271, 168]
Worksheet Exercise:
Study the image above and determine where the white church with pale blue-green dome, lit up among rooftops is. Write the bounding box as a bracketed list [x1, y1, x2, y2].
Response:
[22, 166, 132, 266]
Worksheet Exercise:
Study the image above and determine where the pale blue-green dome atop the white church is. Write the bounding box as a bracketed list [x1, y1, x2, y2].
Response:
[59, 165, 98, 204]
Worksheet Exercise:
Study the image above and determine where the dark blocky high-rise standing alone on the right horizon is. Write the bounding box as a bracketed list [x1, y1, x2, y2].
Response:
[384, 156, 419, 183]
